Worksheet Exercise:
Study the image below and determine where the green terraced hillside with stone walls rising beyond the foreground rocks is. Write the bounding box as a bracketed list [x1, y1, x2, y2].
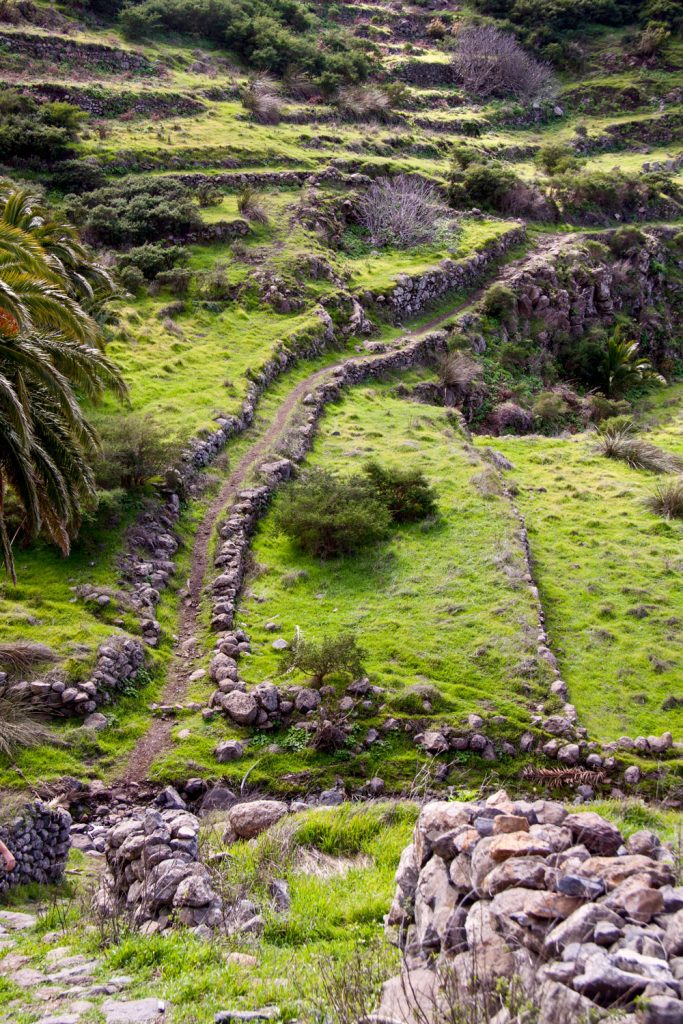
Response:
[0, 0, 683, 799]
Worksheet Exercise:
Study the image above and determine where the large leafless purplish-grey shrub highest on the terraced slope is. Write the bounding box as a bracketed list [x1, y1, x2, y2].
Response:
[453, 26, 551, 99]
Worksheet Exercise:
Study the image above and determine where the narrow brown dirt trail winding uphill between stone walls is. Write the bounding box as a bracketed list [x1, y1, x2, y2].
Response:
[117, 237, 555, 783]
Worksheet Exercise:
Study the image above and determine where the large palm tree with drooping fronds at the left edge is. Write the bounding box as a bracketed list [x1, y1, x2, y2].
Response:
[0, 189, 125, 580]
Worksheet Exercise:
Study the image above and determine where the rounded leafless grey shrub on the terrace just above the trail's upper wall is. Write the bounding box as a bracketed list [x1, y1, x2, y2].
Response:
[358, 174, 452, 248]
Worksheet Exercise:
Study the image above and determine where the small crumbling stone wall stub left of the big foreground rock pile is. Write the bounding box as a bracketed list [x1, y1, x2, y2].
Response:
[96, 808, 223, 934]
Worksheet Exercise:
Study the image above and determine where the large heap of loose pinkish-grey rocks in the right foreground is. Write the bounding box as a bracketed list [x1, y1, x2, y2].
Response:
[380, 792, 683, 1024]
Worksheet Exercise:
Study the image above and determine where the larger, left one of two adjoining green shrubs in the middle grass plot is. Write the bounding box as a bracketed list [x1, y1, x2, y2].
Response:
[274, 469, 391, 558]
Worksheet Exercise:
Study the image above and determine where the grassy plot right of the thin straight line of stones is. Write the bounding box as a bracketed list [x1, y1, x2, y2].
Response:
[485, 420, 683, 740]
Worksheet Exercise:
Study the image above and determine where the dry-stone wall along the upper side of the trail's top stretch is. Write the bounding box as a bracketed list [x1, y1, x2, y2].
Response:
[360, 224, 526, 324]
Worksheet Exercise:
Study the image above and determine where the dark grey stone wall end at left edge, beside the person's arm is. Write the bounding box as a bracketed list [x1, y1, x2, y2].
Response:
[0, 801, 71, 898]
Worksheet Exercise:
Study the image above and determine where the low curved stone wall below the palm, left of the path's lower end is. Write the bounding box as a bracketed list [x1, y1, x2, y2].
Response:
[0, 635, 144, 716]
